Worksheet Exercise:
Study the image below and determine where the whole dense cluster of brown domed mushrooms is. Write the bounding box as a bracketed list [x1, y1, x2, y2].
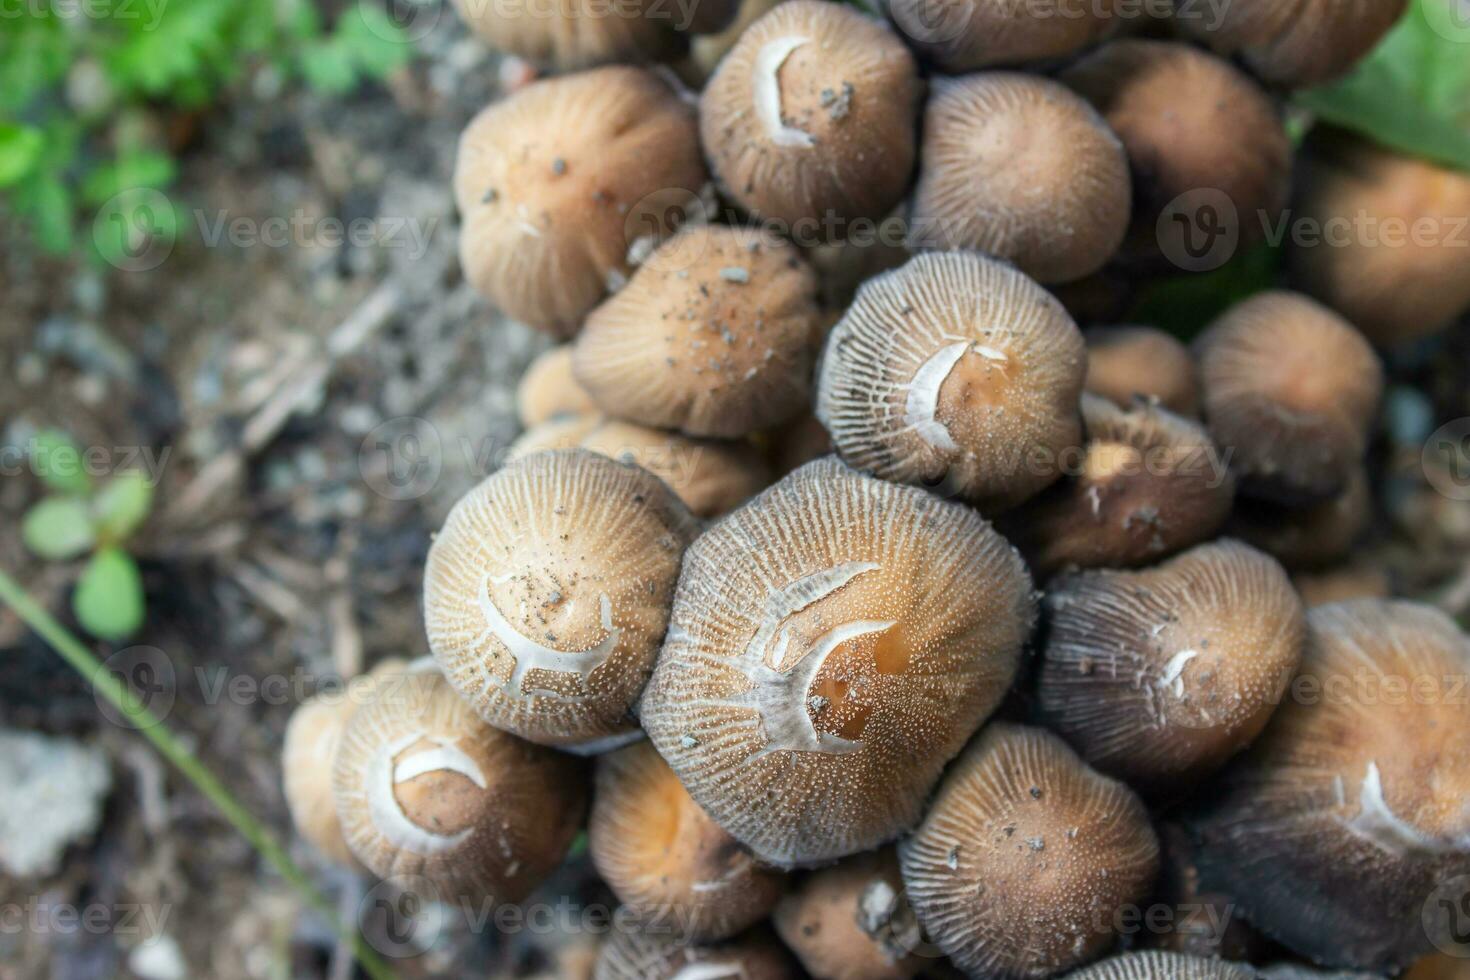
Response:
[277, 0, 1470, 980]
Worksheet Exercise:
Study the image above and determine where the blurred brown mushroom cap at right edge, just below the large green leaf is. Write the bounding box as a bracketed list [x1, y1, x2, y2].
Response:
[1286, 126, 1470, 347]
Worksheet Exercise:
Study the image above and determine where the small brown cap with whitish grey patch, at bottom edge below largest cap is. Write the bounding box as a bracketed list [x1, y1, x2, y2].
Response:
[772, 848, 925, 980]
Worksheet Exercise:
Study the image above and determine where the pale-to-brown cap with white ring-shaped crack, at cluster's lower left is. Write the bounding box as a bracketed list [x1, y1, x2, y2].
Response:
[332, 670, 587, 904]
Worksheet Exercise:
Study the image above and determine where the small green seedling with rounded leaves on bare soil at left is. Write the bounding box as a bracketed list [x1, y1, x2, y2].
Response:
[21, 430, 153, 641]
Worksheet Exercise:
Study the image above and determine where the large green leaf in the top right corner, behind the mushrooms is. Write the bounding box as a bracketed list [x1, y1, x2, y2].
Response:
[1295, 0, 1470, 170]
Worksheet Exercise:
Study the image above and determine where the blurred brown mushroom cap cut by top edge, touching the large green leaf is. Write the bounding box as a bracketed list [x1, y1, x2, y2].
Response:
[1173, 0, 1407, 88]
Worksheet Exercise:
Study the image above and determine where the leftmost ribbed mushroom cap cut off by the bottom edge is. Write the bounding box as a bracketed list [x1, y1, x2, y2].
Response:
[592, 909, 801, 980]
